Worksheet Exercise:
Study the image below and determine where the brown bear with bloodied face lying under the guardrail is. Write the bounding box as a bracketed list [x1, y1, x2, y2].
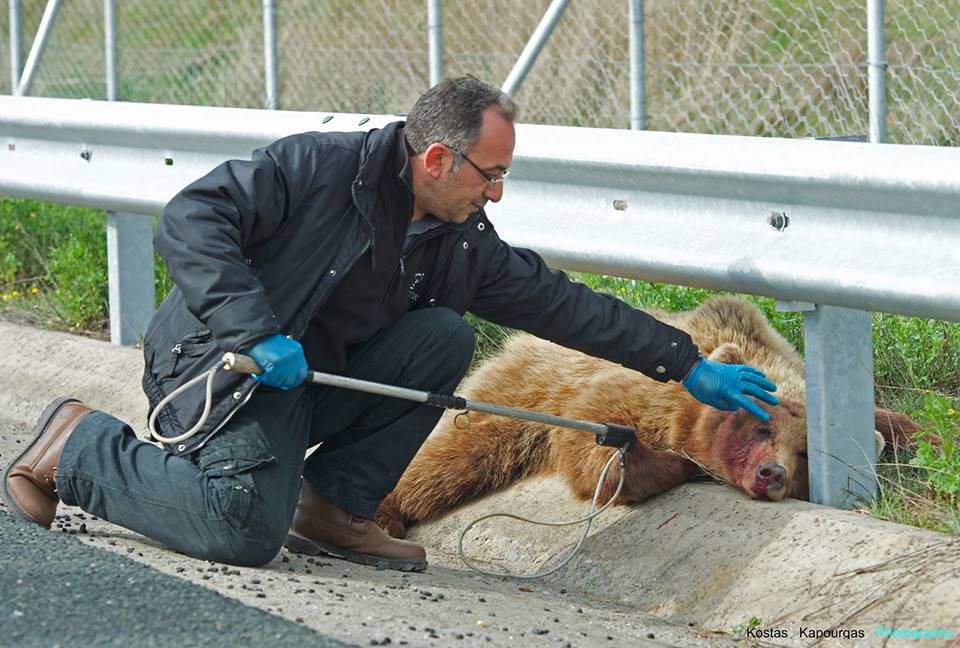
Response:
[377, 297, 919, 537]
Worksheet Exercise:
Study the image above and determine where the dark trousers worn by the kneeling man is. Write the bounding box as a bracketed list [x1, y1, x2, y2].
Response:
[57, 308, 474, 565]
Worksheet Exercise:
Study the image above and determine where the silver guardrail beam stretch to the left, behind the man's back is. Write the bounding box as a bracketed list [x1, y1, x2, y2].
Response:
[0, 96, 401, 216]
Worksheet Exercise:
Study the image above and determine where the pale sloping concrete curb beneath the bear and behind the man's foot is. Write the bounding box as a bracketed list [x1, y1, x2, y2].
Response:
[0, 324, 960, 646]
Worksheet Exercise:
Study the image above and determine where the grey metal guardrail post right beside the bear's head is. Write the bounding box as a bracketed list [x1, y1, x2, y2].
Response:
[803, 304, 877, 508]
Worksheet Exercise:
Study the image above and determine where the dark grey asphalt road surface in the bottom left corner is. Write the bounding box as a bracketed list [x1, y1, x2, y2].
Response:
[0, 511, 348, 648]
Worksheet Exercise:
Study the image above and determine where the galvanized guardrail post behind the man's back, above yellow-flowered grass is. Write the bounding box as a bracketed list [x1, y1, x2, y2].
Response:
[107, 212, 154, 345]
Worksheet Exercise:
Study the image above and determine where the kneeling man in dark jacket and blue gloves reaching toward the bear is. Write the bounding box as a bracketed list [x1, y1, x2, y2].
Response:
[3, 77, 777, 570]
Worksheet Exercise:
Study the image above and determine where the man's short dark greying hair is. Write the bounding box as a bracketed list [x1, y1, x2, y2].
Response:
[404, 74, 517, 166]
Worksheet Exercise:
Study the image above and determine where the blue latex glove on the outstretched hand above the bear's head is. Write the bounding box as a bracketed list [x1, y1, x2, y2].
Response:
[681, 356, 780, 421]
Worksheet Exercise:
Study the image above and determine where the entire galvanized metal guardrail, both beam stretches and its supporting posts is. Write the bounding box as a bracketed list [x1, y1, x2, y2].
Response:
[0, 97, 960, 504]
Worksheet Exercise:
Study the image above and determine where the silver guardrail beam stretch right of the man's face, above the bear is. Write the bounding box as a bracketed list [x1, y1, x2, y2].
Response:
[488, 125, 960, 321]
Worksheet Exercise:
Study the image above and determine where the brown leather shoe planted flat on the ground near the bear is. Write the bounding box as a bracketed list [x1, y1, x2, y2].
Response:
[284, 479, 427, 571]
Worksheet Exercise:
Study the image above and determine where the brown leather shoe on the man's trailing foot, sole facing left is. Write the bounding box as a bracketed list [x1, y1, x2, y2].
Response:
[3, 397, 93, 528]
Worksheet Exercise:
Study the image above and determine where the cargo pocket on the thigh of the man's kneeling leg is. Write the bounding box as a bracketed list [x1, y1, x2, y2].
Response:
[197, 440, 278, 562]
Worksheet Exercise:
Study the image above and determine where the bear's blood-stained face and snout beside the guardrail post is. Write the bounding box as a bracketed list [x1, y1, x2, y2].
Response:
[702, 399, 809, 501]
